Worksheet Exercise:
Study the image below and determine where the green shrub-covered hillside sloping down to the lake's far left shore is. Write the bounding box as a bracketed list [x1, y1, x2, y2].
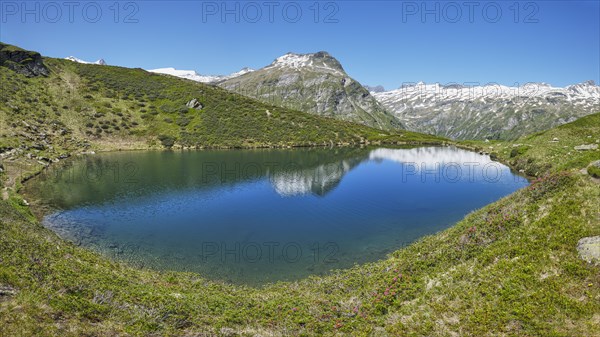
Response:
[0, 44, 444, 188]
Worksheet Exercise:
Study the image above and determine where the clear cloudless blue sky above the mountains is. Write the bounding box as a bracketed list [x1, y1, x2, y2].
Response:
[0, 0, 600, 89]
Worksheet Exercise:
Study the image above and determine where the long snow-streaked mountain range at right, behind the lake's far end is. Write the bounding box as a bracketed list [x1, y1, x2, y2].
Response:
[371, 81, 600, 139]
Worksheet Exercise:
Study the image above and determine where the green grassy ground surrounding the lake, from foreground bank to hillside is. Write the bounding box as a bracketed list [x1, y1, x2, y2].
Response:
[0, 44, 600, 336]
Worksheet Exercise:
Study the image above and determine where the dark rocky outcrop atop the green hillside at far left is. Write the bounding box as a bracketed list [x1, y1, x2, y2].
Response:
[0, 43, 50, 77]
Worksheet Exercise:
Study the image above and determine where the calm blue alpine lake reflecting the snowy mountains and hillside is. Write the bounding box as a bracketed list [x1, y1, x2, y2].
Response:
[26, 147, 527, 285]
